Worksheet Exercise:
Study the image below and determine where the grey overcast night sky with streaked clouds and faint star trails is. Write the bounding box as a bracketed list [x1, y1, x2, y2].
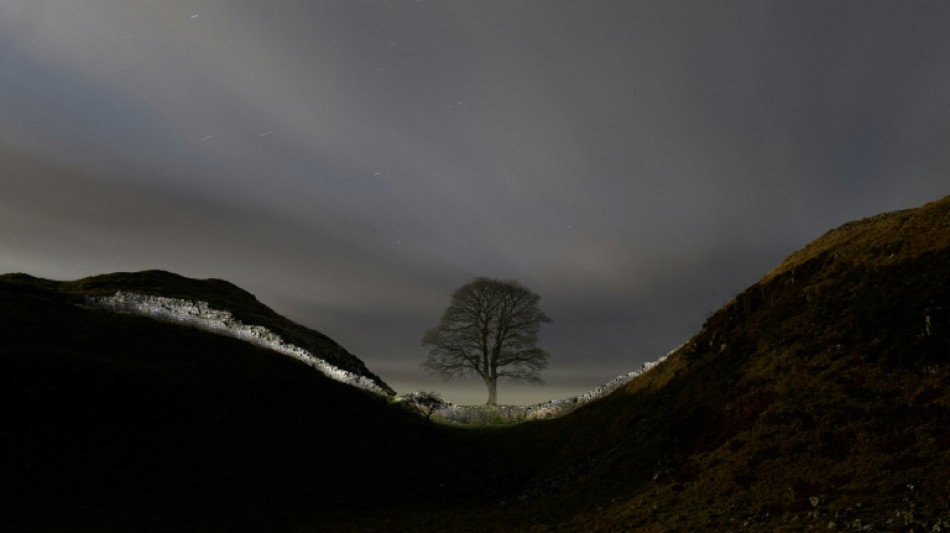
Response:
[0, 0, 950, 403]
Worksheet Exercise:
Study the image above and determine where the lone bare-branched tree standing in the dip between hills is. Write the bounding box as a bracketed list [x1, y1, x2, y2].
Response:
[422, 278, 551, 405]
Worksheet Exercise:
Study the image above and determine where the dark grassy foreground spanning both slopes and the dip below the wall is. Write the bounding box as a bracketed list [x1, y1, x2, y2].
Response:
[0, 198, 950, 531]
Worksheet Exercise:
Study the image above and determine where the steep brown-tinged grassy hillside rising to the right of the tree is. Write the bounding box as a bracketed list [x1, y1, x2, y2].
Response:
[464, 197, 950, 531]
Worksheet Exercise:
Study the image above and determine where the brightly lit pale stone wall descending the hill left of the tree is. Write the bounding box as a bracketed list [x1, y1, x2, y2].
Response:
[87, 291, 388, 396]
